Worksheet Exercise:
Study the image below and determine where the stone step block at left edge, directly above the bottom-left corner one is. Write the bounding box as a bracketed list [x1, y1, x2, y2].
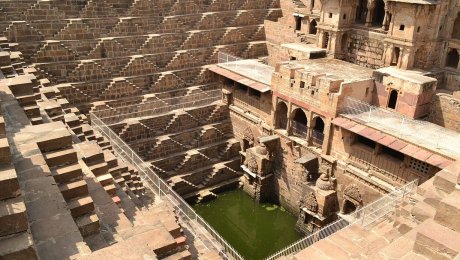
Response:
[0, 196, 28, 236]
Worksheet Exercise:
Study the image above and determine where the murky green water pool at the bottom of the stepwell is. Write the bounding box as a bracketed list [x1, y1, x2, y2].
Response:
[193, 189, 301, 260]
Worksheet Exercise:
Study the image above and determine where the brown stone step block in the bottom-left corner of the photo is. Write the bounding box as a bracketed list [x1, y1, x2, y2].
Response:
[0, 232, 38, 260]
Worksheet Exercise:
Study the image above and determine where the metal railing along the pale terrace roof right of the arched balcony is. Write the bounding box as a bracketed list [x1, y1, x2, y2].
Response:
[339, 97, 460, 154]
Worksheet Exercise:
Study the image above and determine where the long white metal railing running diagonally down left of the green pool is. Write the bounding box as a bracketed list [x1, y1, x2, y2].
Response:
[90, 112, 243, 259]
